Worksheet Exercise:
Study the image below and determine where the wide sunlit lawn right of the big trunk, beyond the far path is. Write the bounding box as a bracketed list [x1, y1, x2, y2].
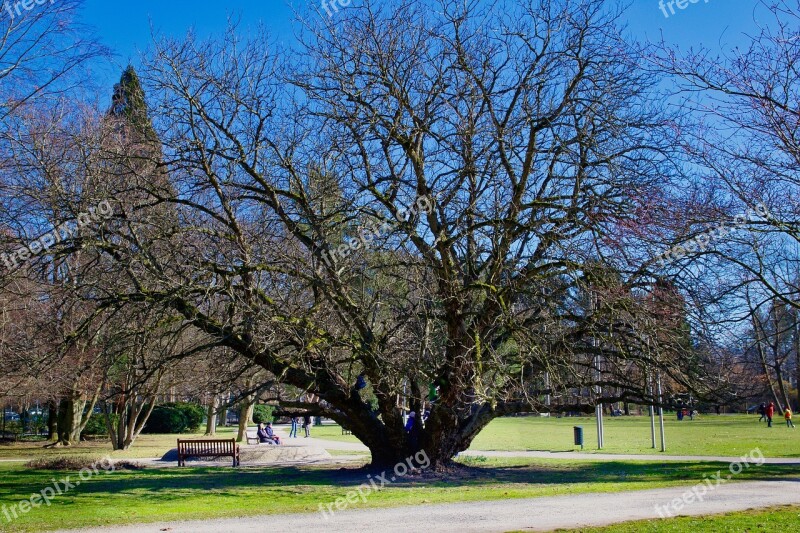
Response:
[471, 415, 800, 457]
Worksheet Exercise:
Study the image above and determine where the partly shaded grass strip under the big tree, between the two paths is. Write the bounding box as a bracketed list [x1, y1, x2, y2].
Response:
[0, 458, 797, 532]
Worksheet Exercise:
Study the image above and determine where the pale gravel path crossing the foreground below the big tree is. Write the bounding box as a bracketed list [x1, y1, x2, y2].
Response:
[54, 478, 800, 533]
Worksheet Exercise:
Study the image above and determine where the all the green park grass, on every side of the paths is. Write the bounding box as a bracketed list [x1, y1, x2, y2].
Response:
[0, 415, 800, 532]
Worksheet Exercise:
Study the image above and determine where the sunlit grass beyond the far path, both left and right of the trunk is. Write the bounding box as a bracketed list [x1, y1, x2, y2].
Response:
[0, 415, 800, 459]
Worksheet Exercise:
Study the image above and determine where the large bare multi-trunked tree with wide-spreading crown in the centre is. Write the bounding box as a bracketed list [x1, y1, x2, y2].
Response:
[67, 0, 712, 467]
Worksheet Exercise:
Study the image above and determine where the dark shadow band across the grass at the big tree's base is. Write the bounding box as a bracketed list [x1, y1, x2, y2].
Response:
[0, 461, 800, 502]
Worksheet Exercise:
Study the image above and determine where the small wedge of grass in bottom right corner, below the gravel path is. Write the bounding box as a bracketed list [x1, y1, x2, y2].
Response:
[573, 506, 800, 533]
